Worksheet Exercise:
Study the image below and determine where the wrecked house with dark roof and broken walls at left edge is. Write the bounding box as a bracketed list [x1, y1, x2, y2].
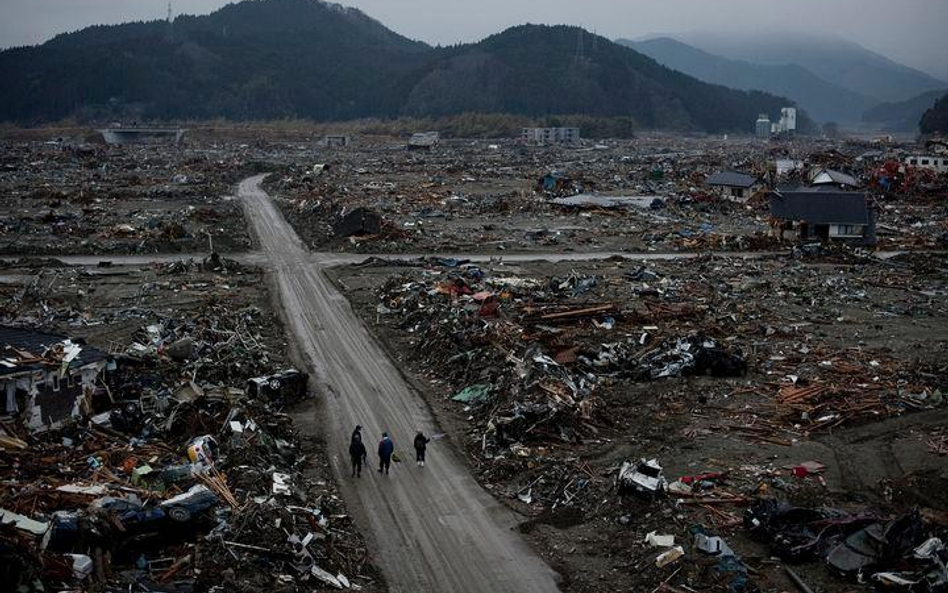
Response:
[0, 325, 108, 432]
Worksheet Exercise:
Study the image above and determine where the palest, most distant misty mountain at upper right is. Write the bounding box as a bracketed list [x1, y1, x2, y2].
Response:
[678, 32, 948, 101]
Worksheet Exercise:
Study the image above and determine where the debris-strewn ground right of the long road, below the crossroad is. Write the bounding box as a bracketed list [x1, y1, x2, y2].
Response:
[337, 250, 948, 591]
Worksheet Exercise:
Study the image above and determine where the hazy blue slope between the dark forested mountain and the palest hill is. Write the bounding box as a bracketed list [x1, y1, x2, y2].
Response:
[616, 37, 876, 123]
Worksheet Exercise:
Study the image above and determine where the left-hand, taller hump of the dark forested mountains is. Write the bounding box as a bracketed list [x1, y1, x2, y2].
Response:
[0, 0, 429, 122]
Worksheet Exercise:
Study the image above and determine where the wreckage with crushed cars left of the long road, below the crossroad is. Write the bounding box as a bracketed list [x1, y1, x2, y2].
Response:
[0, 257, 379, 592]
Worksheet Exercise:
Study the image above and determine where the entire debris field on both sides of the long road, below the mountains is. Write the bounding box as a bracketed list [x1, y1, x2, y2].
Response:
[0, 127, 948, 593]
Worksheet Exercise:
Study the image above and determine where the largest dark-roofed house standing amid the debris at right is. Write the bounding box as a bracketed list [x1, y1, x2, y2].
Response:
[770, 186, 876, 245]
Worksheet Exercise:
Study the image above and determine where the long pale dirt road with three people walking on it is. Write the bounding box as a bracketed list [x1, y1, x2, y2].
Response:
[239, 176, 558, 593]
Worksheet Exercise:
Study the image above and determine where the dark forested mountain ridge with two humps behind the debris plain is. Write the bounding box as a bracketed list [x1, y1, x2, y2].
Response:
[0, 0, 808, 132]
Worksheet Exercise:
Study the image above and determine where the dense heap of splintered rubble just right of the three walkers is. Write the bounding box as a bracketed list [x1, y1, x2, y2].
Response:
[366, 259, 760, 459]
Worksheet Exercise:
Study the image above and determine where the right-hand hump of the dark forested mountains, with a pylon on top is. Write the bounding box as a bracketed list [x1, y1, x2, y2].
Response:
[403, 25, 808, 132]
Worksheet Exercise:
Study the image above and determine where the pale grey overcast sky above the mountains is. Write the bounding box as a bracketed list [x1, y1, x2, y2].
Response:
[0, 0, 948, 80]
